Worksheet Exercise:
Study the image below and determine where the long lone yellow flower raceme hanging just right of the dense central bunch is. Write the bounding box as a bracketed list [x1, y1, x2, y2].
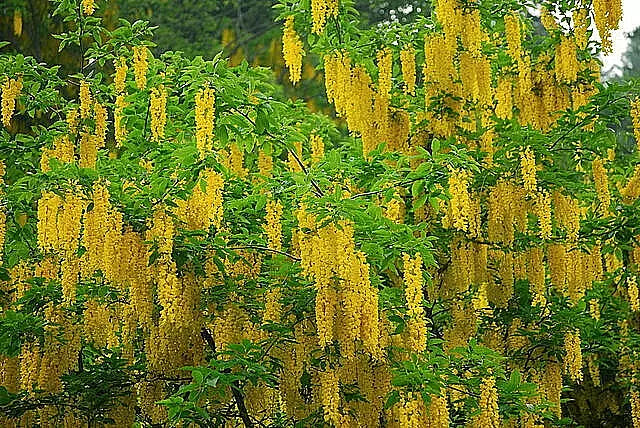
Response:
[402, 254, 427, 353]
